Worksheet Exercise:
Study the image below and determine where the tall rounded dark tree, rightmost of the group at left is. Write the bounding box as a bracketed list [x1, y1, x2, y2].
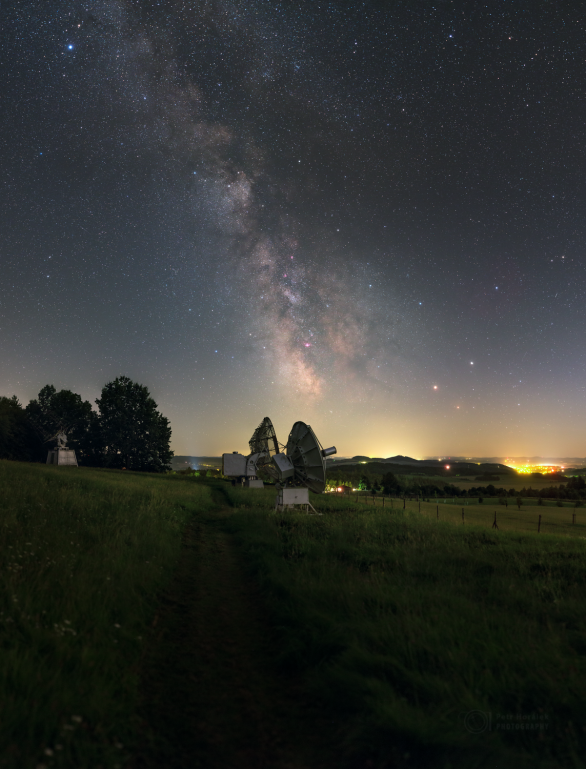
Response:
[96, 376, 173, 473]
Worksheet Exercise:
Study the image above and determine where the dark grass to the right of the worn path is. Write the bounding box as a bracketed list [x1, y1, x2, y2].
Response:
[222, 489, 586, 768]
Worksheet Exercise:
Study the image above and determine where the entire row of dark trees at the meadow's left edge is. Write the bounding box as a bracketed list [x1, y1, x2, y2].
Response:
[0, 376, 173, 473]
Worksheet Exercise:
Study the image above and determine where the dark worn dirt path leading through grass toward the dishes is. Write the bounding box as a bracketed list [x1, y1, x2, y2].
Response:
[134, 510, 338, 769]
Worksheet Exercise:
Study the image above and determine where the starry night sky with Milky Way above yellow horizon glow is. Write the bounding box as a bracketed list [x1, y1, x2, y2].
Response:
[0, 0, 586, 457]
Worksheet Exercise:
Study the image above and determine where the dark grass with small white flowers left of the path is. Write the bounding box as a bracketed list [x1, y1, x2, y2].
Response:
[0, 461, 211, 769]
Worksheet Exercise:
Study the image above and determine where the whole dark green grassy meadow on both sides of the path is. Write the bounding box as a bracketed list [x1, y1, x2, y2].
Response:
[0, 461, 586, 769]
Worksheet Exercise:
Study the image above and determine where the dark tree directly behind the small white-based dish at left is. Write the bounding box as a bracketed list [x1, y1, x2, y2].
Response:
[25, 385, 101, 464]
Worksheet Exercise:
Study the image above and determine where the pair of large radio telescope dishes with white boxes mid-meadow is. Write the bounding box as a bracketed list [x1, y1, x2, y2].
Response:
[222, 417, 336, 512]
